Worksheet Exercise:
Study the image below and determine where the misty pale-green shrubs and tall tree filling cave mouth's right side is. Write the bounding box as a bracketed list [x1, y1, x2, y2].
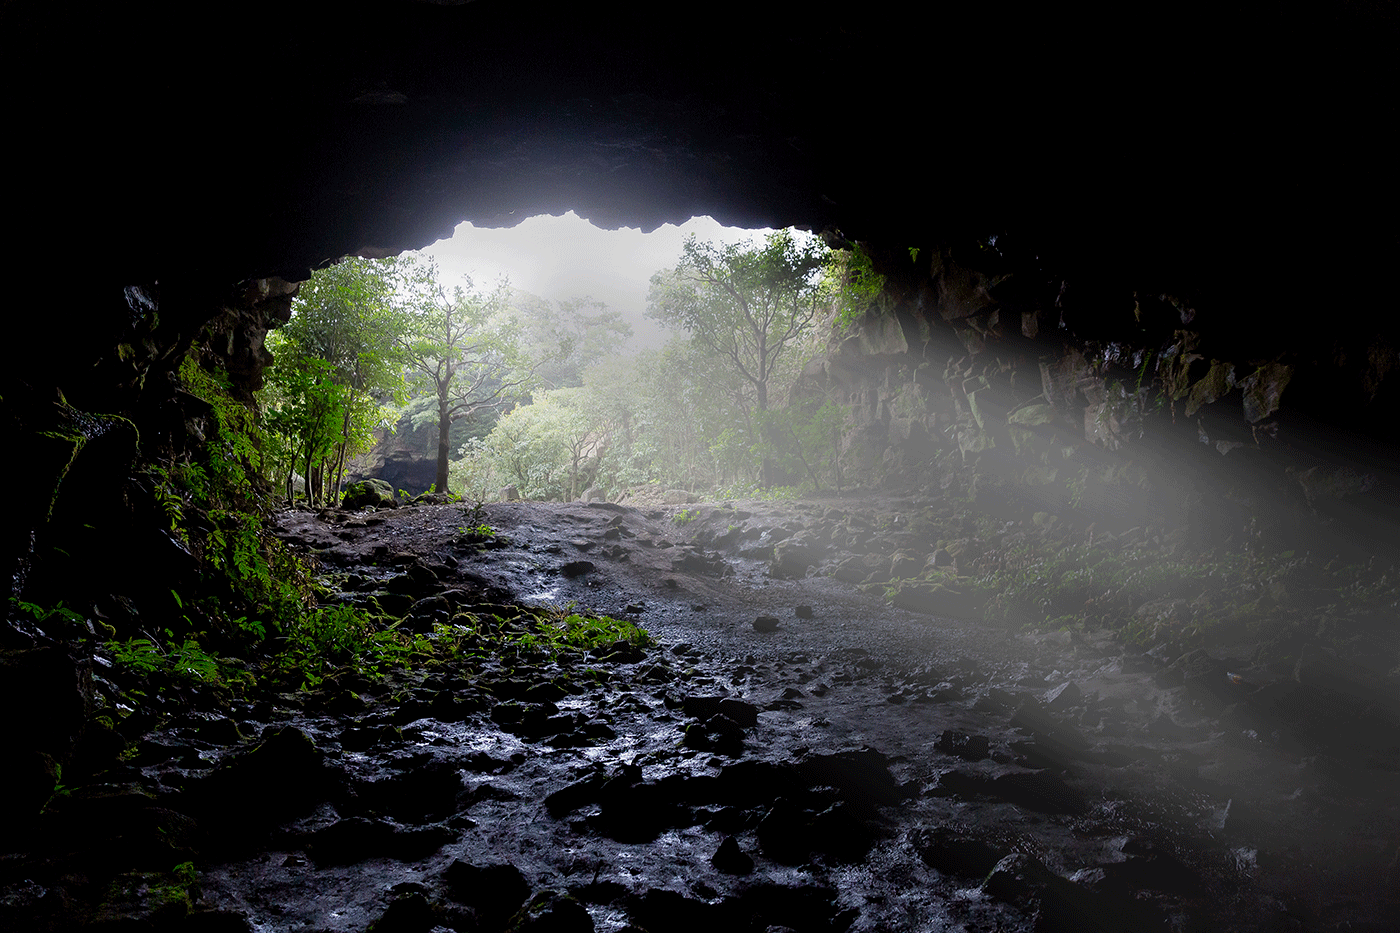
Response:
[452, 231, 881, 499]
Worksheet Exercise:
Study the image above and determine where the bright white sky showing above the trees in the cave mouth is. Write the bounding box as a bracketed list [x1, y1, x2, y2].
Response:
[408, 212, 771, 349]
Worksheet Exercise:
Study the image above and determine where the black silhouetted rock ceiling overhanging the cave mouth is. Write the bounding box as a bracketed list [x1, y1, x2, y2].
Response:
[0, 0, 1400, 406]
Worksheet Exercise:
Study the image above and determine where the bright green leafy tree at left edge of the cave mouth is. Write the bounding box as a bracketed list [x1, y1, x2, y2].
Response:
[259, 259, 405, 502]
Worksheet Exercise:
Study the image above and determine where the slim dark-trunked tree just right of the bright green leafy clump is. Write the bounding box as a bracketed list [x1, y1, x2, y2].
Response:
[400, 257, 536, 492]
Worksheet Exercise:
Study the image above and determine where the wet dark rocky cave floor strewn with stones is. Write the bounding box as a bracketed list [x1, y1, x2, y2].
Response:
[0, 493, 1400, 932]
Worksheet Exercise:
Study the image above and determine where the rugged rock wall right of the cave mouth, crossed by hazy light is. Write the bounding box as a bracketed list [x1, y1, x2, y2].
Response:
[799, 237, 1400, 553]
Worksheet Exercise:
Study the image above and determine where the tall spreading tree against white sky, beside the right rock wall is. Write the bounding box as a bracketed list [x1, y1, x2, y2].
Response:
[647, 230, 826, 486]
